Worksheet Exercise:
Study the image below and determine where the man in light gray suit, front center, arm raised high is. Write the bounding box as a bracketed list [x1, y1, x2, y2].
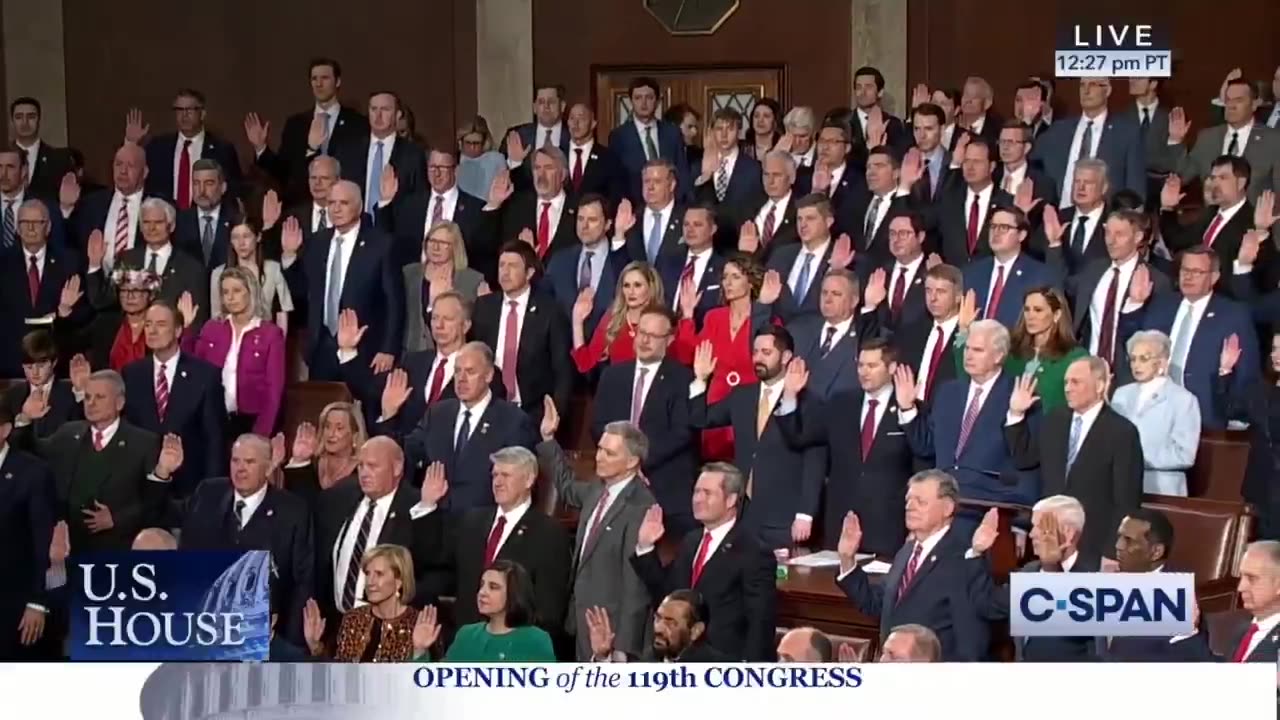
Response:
[538, 397, 658, 662]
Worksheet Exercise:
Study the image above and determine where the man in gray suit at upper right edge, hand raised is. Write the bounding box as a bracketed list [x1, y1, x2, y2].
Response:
[1169, 79, 1280, 202]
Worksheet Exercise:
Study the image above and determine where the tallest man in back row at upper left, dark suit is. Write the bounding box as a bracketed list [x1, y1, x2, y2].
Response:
[244, 58, 369, 204]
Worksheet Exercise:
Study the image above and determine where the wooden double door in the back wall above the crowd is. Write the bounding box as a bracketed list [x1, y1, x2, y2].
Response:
[593, 65, 787, 140]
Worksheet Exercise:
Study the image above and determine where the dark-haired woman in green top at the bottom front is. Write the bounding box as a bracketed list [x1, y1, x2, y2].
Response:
[420, 560, 556, 662]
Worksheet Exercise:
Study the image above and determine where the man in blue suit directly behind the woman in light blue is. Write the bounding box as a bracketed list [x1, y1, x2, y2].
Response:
[1120, 245, 1262, 430]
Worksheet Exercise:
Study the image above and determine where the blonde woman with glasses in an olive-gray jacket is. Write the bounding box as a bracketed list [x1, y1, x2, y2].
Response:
[403, 222, 488, 354]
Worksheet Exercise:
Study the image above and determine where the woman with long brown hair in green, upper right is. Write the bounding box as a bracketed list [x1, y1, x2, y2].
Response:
[954, 286, 1089, 411]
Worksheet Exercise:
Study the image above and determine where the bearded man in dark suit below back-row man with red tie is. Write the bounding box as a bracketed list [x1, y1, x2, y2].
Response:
[173, 159, 241, 273]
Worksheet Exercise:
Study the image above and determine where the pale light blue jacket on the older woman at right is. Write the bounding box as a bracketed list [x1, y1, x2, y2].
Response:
[1111, 378, 1201, 497]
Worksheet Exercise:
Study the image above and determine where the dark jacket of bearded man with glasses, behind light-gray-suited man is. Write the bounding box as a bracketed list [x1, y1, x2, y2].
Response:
[591, 357, 698, 515]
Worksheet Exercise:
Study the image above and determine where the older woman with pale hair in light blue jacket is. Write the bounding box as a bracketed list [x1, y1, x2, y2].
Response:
[1111, 331, 1201, 497]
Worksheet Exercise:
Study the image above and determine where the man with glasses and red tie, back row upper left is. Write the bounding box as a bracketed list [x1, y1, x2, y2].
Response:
[144, 87, 241, 203]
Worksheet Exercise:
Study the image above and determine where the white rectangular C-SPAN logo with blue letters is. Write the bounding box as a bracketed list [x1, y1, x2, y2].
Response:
[1009, 573, 1196, 637]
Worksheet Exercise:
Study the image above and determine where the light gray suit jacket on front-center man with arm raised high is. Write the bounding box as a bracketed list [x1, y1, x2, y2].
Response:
[538, 441, 657, 662]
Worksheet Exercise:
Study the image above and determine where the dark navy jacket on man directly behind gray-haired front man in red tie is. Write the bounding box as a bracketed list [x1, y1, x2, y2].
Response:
[404, 397, 538, 512]
